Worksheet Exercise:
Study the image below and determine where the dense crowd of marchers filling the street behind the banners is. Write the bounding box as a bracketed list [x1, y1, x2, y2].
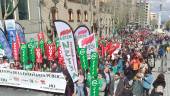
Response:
[0, 28, 170, 96]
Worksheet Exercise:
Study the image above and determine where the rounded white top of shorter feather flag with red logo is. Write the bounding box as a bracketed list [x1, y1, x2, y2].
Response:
[74, 25, 90, 44]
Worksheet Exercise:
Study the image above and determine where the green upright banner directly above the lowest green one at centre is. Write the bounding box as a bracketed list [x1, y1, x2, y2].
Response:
[90, 52, 99, 78]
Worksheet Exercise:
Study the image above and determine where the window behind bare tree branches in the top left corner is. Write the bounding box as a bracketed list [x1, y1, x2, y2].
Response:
[0, 0, 14, 19]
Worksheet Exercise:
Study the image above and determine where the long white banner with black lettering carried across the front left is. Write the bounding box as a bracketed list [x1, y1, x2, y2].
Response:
[0, 68, 66, 93]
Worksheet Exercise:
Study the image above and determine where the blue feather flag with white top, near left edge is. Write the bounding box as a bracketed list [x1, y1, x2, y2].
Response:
[5, 19, 16, 48]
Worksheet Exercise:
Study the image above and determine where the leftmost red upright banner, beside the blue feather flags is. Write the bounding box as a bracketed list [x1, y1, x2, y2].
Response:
[12, 42, 19, 61]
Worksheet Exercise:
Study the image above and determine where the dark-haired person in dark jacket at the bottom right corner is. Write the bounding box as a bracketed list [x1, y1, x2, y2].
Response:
[150, 73, 166, 96]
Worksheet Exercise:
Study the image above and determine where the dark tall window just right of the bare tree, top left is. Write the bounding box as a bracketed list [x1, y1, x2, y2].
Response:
[18, 0, 29, 20]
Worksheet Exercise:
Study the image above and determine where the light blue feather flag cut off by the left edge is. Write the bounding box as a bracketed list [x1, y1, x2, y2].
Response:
[0, 29, 12, 58]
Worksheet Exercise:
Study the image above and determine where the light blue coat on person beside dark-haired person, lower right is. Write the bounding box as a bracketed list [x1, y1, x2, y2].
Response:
[143, 74, 154, 89]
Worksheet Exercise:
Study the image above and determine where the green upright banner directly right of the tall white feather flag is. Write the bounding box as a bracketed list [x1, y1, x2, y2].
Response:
[78, 48, 88, 71]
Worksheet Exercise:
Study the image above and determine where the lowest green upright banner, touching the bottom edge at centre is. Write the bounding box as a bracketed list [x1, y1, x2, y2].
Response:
[90, 79, 99, 96]
